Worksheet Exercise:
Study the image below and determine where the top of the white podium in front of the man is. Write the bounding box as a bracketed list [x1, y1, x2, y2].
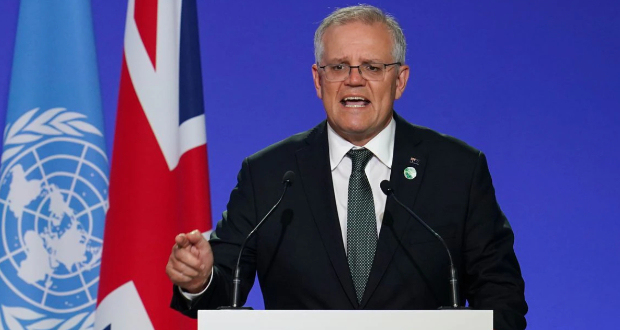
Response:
[198, 310, 493, 330]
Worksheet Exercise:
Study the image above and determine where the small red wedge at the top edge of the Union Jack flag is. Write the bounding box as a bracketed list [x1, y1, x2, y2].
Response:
[133, 0, 157, 68]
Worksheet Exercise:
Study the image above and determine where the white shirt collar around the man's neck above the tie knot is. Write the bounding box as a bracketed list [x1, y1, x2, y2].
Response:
[327, 118, 396, 171]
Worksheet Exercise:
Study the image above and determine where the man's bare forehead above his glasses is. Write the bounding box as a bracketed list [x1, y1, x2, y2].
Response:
[323, 21, 393, 62]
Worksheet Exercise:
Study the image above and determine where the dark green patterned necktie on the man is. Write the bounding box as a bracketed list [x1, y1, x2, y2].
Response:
[347, 149, 377, 302]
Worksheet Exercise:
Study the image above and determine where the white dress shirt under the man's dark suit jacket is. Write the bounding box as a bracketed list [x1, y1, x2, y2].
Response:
[327, 118, 396, 250]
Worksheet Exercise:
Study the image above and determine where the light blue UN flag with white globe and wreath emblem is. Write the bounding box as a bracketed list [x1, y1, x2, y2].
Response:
[0, 0, 109, 330]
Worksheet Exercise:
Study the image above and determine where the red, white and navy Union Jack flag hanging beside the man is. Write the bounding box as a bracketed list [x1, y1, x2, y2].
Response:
[95, 0, 211, 330]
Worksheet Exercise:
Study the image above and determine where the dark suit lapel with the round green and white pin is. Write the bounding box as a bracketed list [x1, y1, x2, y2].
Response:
[361, 114, 427, 308]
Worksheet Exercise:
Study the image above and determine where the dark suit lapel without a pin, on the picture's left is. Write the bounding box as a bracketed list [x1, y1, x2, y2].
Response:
[296, 122, 358, 307]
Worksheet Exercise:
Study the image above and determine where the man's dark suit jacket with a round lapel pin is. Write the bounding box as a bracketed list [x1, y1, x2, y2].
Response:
[172, 115, 527, 330]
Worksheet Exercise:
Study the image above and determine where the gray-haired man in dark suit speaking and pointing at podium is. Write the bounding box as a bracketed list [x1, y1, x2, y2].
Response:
[166, 6, 527, 330]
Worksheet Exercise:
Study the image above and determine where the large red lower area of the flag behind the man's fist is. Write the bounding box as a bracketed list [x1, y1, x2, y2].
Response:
[98, 61, 211, 330]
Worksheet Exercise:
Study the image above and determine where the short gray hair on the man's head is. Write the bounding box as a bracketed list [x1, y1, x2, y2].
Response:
[314, 4, 407, 64]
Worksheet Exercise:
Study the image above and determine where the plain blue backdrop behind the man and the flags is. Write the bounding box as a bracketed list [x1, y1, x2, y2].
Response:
[0, 0, 620, 329]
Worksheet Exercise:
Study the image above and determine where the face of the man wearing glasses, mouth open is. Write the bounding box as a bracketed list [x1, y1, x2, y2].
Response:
[312, 22, 409, 146]
